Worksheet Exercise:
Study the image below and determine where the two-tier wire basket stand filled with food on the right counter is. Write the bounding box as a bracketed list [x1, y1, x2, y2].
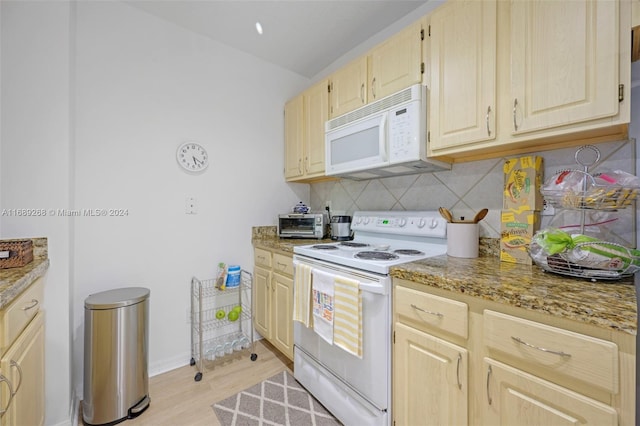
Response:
[529, 145, 640, 281]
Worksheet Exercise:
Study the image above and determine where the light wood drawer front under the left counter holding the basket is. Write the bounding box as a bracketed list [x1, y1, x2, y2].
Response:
[0, 278, 44, 353]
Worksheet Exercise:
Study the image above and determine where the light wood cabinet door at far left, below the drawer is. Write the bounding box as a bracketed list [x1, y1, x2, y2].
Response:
[0, 311, 44, 426]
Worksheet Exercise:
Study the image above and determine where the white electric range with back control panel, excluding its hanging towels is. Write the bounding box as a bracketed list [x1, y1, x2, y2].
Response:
[294, 211, 447, 426]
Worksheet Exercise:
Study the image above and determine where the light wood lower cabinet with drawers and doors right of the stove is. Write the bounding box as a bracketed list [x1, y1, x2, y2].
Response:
[392, 279, 636, 426]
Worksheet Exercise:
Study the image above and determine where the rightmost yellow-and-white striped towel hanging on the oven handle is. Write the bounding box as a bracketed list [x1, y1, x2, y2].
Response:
[333, 277, 362, 359]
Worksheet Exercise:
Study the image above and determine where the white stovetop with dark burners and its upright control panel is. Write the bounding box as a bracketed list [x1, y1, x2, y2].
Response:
[294, 211, 447, 274]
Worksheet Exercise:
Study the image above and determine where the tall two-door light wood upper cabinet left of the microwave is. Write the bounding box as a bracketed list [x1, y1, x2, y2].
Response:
[285, 80, 329, 181]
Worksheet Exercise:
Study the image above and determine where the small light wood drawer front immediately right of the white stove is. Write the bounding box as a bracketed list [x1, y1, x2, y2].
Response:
[395, 286, 469, 339]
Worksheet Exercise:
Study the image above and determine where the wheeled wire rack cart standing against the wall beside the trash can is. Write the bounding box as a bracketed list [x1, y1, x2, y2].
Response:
[191, 270, 258, 382]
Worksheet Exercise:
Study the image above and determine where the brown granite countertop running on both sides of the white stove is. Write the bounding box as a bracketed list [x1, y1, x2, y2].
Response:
[252, 227, 638, 336]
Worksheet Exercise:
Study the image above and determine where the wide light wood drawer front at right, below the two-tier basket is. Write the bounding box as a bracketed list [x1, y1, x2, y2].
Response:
[484, 310, 619, 394]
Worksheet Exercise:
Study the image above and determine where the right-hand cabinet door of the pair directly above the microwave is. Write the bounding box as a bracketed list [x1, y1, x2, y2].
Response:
[369, 21, 424, 102]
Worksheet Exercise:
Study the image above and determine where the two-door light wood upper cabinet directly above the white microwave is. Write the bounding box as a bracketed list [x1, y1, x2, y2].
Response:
[330, 20, 424, 118]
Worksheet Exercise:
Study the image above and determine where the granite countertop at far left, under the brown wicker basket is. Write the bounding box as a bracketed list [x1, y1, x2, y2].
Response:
[0, 238, 49, 309]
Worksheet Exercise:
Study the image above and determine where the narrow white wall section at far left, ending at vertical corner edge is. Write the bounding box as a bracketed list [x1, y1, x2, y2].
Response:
[0, 1, 72, 424]
